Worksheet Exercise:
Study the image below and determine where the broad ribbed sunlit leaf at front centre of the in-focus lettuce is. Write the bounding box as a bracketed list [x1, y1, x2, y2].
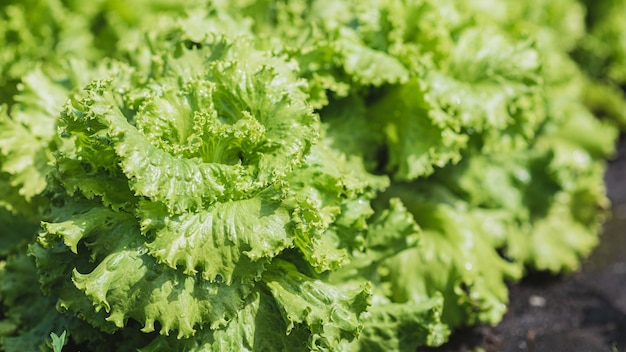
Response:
[138, 188, 293, 285]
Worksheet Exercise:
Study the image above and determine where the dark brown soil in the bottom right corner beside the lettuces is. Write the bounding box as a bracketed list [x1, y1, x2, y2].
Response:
[418, 139, 626, 352]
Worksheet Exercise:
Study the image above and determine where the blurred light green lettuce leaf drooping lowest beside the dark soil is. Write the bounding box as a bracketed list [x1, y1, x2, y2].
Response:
[382, 184, 522, 327]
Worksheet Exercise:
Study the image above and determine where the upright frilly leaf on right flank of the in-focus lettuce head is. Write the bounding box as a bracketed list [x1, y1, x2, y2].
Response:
[287, 140, 388, 272]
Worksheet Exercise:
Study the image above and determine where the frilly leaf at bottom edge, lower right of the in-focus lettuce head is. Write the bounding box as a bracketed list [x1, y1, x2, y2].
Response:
[141, 259, 371, 351]
